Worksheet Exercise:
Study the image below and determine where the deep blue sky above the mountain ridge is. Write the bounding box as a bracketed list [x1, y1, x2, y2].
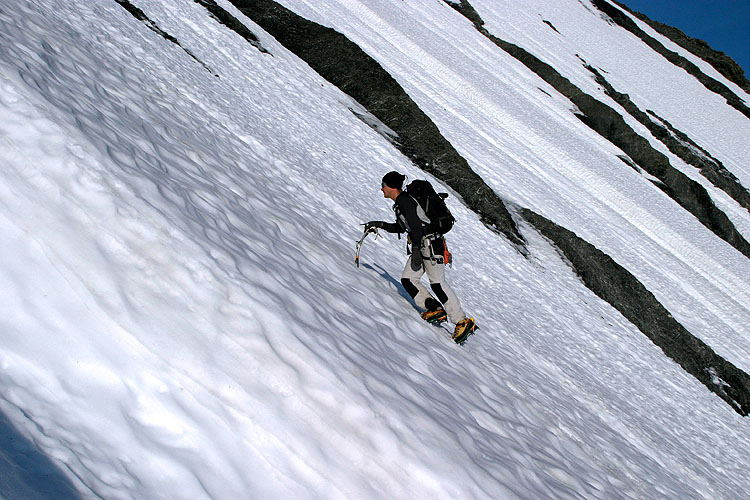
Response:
[621, 0, 750, 78]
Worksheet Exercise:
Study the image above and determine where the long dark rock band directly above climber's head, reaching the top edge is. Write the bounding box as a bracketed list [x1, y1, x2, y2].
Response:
[232, 0, 525, 248]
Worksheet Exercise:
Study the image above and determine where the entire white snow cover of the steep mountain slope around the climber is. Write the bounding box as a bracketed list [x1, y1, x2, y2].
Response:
[0, 0, 750, 500]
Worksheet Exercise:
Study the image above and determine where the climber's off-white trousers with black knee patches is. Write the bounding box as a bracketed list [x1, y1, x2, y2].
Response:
[401, 239, 466, 324]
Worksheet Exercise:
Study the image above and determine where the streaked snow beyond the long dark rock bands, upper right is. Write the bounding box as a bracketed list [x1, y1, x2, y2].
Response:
[284, 0, 750, 370]
